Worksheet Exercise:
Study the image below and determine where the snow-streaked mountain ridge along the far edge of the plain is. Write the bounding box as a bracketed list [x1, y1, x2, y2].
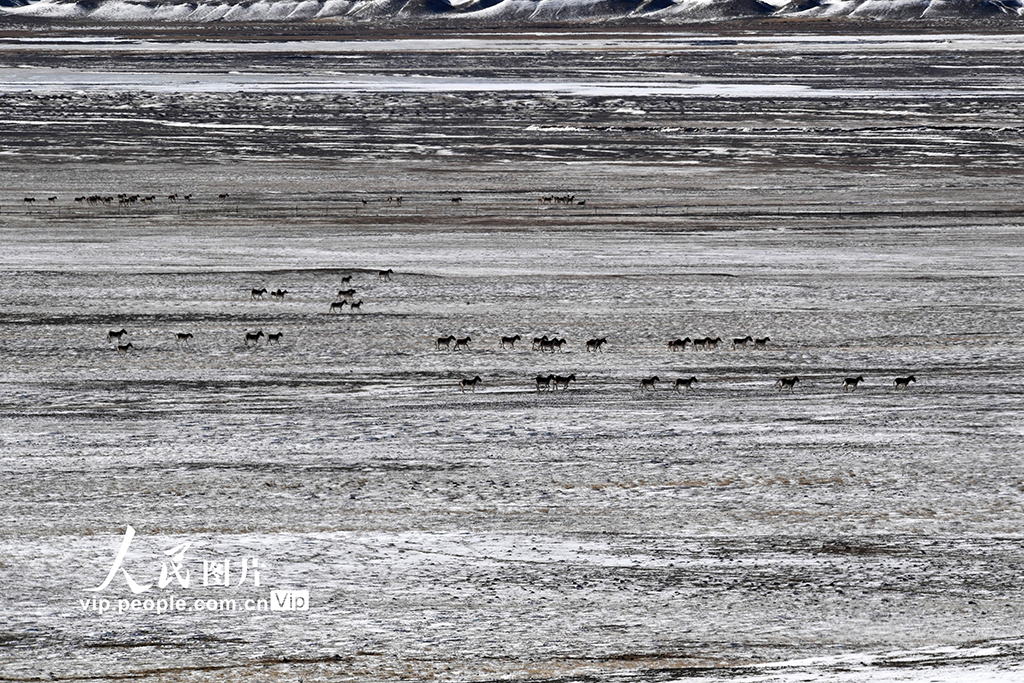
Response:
[0, 0, 1024, 23]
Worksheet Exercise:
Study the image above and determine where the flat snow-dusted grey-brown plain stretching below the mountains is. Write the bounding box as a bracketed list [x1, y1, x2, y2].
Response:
[0, 25, 1024, 682]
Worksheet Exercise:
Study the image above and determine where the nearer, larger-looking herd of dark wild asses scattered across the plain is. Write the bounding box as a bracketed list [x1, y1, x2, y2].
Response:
[106, 268, 916, 392]
